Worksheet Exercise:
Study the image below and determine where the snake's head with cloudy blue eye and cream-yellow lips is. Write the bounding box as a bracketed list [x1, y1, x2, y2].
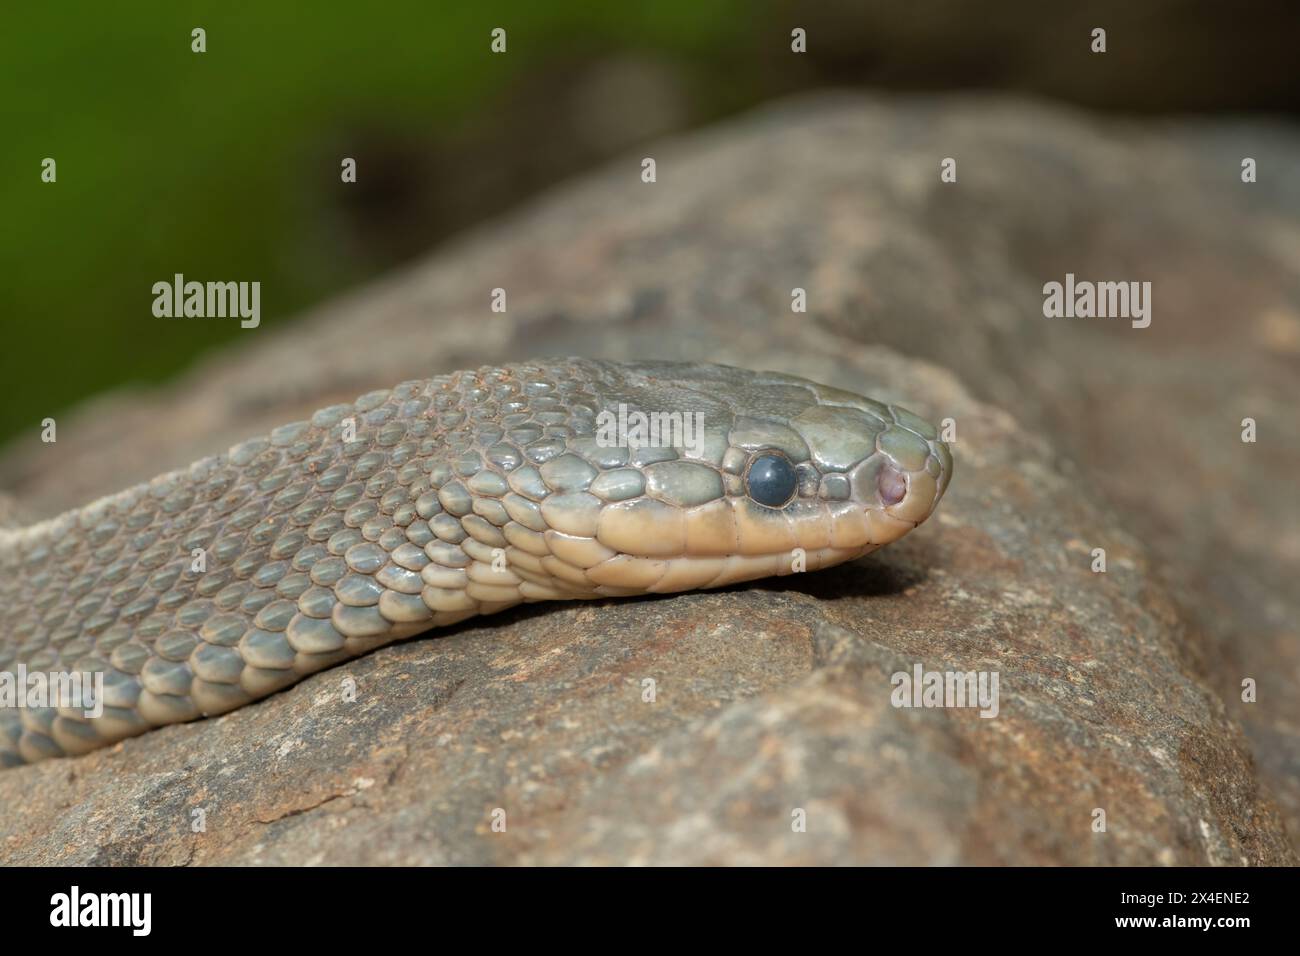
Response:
[541, 363, 953, 593]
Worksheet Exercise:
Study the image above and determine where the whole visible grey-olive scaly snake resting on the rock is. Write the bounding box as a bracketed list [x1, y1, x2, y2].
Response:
[0, 358, 953, 767]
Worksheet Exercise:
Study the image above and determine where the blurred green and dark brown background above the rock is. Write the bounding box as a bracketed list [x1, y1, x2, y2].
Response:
[0, 0, 1300, 444]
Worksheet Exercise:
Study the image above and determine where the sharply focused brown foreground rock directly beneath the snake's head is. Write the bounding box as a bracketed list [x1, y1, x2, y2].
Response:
[0, 347, 1292, 865]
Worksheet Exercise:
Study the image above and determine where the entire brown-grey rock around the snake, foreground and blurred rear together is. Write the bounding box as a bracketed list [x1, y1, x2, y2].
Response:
[0, 96, 1300, 864]
